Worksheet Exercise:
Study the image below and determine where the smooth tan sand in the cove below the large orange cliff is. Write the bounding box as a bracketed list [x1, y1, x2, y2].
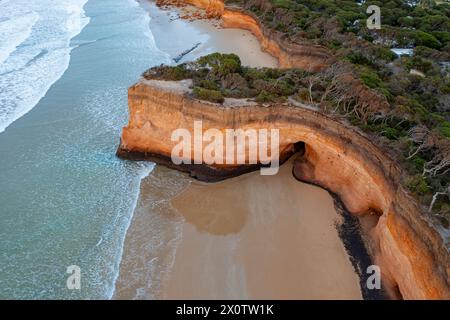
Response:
[163, 161, 361, 299]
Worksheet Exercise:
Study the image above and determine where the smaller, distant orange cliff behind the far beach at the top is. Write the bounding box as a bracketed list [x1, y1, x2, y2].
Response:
[157, 0, 334, 71]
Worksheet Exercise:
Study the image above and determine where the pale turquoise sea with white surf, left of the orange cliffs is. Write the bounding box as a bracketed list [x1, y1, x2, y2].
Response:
[0, 0, 170, 299]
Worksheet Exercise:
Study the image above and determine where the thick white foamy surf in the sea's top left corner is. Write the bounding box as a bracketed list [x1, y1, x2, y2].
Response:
[0, 0, 89, 133]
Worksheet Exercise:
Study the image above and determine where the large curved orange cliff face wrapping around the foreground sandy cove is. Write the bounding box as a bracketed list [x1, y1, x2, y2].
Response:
[118, 80, 450, 299]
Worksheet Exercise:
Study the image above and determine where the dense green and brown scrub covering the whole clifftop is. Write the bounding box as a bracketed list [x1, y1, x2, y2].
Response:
[144, 0, 450, 227]
